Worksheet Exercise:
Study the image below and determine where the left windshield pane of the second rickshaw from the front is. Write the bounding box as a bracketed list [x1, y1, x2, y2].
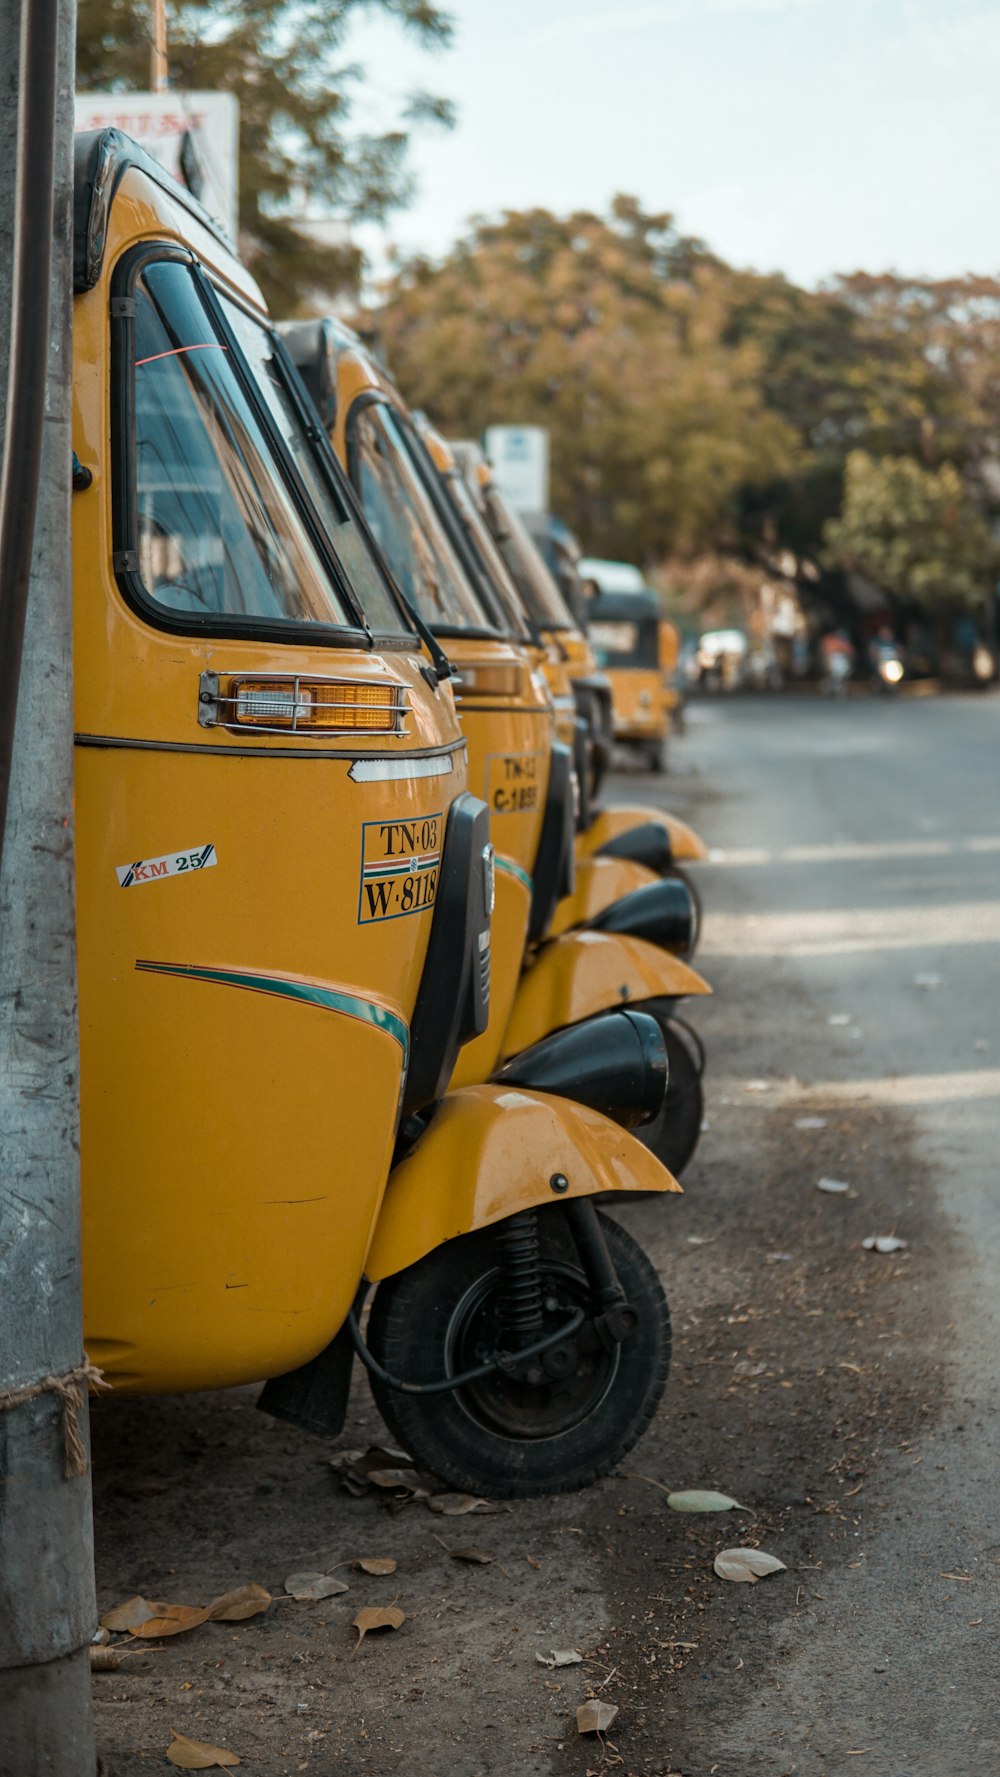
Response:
[350, 402, 494, 631]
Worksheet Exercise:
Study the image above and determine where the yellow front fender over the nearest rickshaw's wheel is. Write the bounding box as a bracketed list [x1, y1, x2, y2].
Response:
[364, 1086, 680, 1283]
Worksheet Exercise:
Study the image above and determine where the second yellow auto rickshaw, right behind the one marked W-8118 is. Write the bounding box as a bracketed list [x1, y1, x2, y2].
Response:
[284, 322, 709, 1164]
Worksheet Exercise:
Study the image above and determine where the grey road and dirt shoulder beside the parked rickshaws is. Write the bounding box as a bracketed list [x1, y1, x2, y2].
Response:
[94, 697, 1000, 1777]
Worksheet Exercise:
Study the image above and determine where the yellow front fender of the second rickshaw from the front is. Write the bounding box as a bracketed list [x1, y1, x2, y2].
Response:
[501, 931, 712, 1061]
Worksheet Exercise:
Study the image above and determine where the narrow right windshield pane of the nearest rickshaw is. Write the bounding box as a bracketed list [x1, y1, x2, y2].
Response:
[220, 297, 412, 636]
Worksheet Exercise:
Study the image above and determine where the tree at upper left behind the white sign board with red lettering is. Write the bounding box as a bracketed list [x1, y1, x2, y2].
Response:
[76, 0, 453, 315]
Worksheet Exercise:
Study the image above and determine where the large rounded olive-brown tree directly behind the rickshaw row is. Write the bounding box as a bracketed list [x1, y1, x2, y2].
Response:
[369, 197, 792, 562]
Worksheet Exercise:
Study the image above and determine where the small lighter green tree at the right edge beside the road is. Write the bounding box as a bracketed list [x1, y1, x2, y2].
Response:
[826, 451, 1000, 617]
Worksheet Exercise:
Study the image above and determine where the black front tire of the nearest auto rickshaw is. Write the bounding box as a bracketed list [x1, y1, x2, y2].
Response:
[368, 1205, 670, 1500]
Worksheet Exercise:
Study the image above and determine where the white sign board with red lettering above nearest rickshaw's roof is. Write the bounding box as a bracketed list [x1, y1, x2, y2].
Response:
[76, 92, 240, 240]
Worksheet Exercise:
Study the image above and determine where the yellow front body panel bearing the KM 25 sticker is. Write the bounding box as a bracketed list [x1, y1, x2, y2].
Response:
[73, 159, 467, 1390]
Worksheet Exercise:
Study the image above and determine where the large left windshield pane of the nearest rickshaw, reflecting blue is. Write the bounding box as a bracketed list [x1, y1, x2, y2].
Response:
[123, 259, 357, 633]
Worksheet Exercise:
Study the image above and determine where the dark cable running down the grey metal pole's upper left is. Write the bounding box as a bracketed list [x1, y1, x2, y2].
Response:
[0, 0, 58, 855]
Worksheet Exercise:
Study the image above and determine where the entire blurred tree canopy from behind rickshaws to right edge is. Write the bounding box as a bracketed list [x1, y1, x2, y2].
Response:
[366, 197, 1000, 629]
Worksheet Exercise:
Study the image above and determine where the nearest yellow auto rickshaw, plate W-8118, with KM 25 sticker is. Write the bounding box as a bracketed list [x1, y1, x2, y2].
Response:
[73, 130, 679, 1494]
